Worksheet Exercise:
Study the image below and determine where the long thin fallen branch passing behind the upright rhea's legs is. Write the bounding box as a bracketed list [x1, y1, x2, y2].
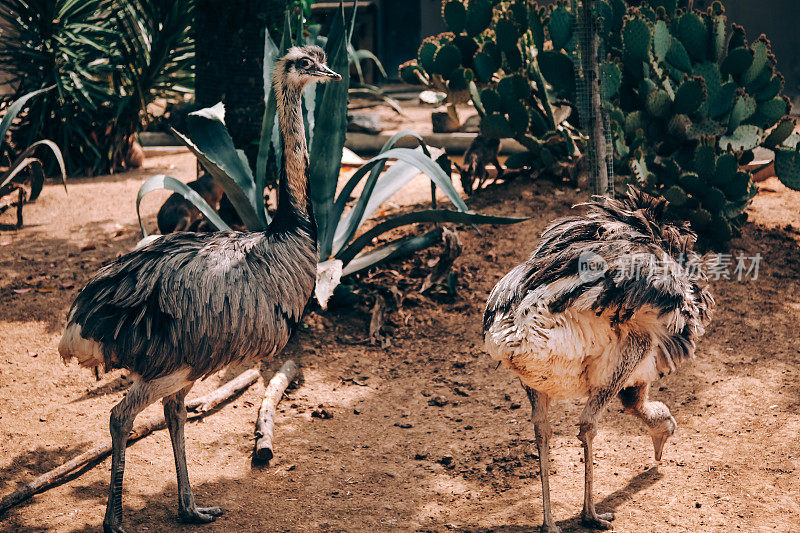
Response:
[0, 369, 259, 515]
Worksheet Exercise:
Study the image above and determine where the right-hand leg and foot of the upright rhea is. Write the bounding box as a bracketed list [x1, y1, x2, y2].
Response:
[163, 384, 222, 524]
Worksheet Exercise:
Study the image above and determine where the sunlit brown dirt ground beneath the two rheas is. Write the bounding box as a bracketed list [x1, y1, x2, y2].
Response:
[0, 151, 800, 533]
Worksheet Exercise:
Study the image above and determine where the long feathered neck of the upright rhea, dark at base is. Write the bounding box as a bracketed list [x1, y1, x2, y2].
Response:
[270, 70, 317, 238]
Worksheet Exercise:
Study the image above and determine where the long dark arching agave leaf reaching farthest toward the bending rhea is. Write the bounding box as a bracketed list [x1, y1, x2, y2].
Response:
[336, 209, 528, 265]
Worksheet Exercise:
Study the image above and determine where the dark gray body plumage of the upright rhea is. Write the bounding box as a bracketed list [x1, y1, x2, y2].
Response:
[70, 232, 317, 379]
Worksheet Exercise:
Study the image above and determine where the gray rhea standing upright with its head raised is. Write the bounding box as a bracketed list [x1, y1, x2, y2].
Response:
[58, 46, 341, 532]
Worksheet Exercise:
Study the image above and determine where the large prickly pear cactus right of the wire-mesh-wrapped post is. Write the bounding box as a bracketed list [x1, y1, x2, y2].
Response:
[597, 0, 800, 244]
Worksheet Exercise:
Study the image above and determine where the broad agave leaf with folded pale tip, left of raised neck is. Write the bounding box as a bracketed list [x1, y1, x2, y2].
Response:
[172, 103, 267, 231]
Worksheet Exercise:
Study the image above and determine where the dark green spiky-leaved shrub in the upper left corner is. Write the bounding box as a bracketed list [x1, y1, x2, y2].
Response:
[0, 0, 194, 175]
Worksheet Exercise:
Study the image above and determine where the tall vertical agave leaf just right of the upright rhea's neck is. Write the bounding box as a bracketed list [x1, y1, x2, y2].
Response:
[309, 2, 355, 259]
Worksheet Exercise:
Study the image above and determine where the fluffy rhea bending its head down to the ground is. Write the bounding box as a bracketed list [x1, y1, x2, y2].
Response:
[483, 189, 714, 532]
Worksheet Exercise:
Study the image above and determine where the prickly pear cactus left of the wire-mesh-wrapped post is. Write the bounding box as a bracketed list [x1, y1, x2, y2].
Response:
[400, 0, 580, 180]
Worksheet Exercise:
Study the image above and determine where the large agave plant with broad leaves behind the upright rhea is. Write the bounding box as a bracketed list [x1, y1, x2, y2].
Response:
[137, 1, 523, 300]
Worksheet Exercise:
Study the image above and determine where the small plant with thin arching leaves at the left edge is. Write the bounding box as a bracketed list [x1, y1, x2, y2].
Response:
[0, 87, 67, 227]
